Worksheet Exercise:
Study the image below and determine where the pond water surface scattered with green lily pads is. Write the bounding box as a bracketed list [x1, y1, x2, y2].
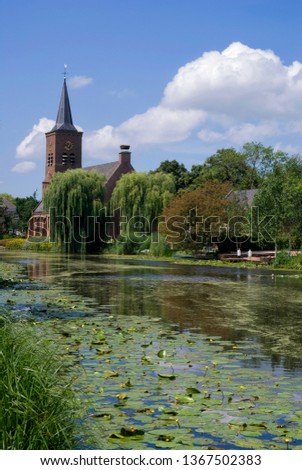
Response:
[2, 254, 302, 449]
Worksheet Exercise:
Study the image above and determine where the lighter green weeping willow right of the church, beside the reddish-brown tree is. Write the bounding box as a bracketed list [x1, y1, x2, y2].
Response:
[111, 172, 175, 233]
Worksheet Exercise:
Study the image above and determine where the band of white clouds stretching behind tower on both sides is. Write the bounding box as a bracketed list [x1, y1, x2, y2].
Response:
[17, 42, 302, 160]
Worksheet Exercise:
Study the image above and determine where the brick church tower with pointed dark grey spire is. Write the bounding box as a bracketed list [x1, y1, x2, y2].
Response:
[42, 76, 83, 194]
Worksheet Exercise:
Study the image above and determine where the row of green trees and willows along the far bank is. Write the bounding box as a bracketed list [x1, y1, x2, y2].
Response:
[0, 142, 302, 252]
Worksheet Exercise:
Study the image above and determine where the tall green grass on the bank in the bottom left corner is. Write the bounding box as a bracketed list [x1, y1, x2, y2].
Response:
[0, 316, 74, 450]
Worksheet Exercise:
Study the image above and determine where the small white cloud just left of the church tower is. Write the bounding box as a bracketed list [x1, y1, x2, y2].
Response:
[16, 118, 55, 159]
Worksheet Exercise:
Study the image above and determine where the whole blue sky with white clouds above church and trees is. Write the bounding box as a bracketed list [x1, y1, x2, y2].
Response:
[0, 0, 302, 196]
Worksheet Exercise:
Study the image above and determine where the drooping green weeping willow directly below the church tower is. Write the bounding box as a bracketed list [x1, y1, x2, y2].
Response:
[43, 169, 105, 253]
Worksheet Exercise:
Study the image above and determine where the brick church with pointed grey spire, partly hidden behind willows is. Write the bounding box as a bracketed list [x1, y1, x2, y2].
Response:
[28, 76, 134, 237]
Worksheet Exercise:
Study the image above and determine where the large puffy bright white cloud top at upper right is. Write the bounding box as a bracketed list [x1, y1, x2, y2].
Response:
[163, 42, 302, 120]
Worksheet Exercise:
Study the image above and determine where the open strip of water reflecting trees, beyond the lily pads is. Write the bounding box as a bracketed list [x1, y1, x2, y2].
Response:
[4, 255, 302, 370]
